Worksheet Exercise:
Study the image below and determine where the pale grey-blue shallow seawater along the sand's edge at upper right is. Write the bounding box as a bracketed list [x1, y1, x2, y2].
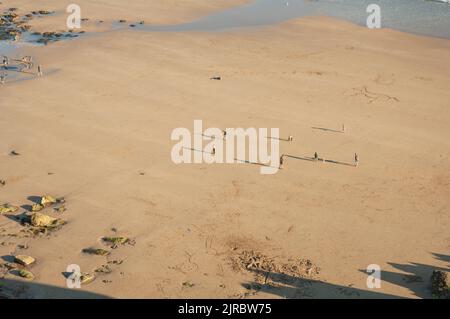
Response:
[136, 0, 450, 38]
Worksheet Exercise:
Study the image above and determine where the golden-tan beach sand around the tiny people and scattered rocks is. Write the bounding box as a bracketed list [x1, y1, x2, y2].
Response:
[0, 1, 450, 298]
